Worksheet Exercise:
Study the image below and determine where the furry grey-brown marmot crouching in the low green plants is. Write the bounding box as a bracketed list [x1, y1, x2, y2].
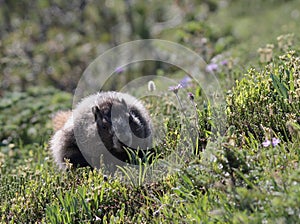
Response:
[50, 91, 152, 169]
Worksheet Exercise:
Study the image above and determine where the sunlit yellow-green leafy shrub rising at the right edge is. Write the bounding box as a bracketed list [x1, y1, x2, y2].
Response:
[227, 51, 300, 143]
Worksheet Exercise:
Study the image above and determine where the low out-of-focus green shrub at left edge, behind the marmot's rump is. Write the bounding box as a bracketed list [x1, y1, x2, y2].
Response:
[0, 87, 72, 144]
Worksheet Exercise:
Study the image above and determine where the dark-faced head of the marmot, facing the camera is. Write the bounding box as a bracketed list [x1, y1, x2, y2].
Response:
[92, 99, 151, 160]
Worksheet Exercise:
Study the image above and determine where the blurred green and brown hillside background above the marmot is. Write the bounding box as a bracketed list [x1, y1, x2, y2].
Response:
[0, 0, 300, 93]
